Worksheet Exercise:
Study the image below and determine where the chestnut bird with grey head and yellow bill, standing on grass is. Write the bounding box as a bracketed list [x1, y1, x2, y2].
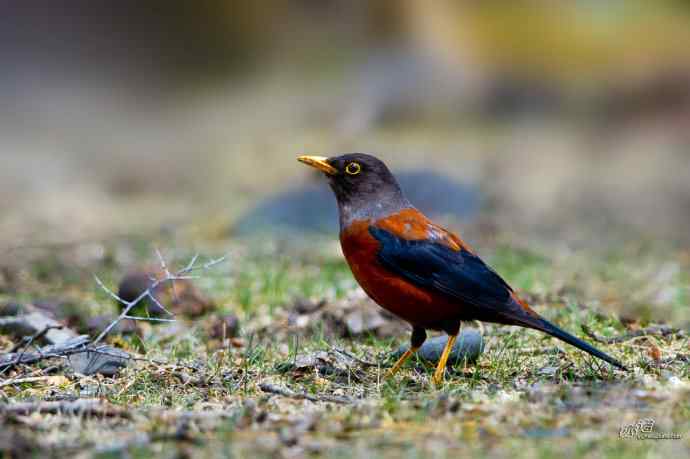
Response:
[297, 153, 627, 385]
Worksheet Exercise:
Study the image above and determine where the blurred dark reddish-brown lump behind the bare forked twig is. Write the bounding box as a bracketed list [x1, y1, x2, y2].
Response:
[118, 269, 215, 318]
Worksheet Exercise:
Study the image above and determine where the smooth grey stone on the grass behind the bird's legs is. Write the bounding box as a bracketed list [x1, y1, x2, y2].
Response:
[393, 328, 484, 367]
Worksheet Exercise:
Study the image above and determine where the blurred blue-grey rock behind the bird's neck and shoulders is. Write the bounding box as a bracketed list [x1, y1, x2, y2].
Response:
[233, 170, 483, 236]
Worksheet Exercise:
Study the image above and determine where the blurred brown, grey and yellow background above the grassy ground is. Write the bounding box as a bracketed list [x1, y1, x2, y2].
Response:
[0, 0, 690, 253]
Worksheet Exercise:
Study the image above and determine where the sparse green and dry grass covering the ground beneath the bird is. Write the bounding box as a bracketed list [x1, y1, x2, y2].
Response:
[0, 234, 690, 458]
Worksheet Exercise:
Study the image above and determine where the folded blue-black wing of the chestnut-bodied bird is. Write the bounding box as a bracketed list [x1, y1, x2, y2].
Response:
[369, 226, 513, 312]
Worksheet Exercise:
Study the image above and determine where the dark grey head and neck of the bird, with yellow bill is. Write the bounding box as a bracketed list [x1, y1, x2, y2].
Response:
[298, 153, 412, 229]
